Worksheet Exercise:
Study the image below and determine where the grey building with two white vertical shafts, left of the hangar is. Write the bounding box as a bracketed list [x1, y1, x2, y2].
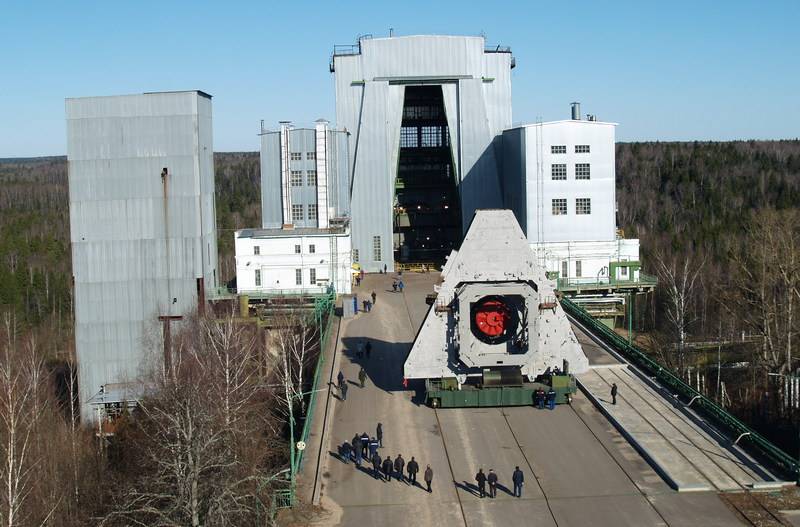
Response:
[260, 119, 350, 229]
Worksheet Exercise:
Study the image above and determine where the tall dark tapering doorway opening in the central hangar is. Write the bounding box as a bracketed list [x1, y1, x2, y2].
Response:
[394, 85, 461, 263]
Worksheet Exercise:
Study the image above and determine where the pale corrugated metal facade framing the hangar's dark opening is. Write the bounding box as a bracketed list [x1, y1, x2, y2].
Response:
[334, 36, 511, 271]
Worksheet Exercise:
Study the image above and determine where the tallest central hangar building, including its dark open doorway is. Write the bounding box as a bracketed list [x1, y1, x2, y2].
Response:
[330, 35, 514, 272]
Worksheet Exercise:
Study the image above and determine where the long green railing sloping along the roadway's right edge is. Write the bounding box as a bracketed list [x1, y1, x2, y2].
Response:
[561, 298, 800, 479]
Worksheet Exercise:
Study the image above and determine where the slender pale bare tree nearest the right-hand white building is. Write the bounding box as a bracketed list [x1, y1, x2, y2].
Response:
[654, 255, 705, 374]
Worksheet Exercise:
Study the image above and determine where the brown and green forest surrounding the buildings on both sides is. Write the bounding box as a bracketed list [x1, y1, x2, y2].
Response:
[0, 140, 800, 526]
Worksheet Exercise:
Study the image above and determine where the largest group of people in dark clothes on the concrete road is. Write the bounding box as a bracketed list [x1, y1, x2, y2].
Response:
[339, 423, 433, 492]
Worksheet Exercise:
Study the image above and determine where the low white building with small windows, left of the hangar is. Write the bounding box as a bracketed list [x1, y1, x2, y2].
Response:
[235, 227, 352, 295]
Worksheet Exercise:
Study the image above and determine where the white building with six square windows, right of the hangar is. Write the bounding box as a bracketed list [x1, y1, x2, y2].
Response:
[503, 103, 647, 318]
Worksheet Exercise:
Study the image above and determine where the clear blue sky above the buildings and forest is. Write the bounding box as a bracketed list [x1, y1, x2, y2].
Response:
[0, 0, 800, 157]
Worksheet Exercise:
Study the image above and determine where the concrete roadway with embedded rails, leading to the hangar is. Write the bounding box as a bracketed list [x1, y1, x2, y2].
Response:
[314, 273, 738, 527]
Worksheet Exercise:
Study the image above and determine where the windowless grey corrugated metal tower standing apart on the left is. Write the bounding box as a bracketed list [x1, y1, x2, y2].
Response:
[66, 91, 217, 420]
